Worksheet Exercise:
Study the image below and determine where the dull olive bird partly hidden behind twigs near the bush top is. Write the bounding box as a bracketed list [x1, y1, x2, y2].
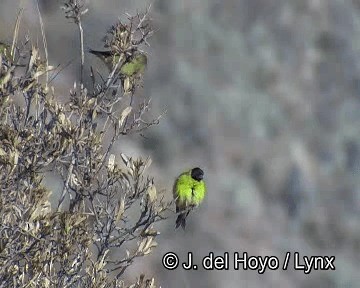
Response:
[89, 49, 147, 91]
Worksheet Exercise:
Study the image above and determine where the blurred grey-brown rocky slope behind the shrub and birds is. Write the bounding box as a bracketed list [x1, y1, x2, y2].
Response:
[0, 0, 360, 288]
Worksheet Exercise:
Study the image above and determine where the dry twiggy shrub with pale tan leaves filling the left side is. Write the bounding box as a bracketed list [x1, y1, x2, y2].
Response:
[0, 1, 170, 287]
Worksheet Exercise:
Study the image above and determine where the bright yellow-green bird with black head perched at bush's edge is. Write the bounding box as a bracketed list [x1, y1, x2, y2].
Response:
[173, 167, 206, 229]
